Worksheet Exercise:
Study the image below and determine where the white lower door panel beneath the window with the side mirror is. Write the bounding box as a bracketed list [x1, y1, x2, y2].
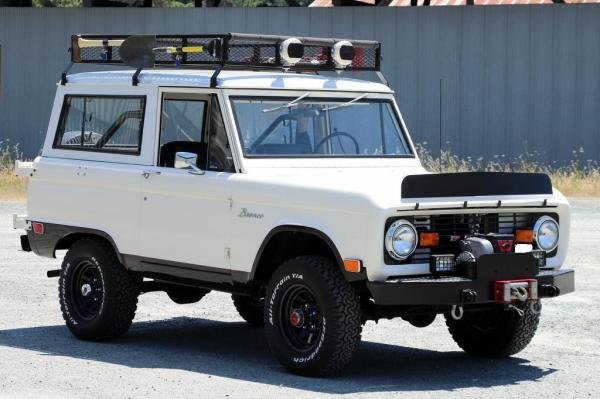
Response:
[139, 168, 231, 269]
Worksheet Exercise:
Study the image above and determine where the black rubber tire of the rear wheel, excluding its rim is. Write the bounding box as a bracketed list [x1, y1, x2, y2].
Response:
[58, 239, 141, 341]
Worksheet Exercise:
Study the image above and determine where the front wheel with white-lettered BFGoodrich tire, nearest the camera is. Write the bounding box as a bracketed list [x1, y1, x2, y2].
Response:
[265, 256, 362, 376]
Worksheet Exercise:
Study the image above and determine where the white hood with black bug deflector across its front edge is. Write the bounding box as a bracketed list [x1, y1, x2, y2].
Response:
[237, 166, 554, 209]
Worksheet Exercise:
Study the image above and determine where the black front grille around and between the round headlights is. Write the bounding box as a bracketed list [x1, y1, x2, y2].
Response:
[384, 213, 558, 264]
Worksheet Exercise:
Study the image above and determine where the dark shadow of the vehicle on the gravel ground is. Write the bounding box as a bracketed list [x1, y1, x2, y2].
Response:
[0, 317, 556, 394]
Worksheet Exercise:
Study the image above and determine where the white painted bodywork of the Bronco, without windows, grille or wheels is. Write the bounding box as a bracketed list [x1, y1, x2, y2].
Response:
[22, 71, 570, 281]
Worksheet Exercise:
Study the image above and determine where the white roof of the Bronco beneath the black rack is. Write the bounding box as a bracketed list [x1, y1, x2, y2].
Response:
[67, 69, 392, 93]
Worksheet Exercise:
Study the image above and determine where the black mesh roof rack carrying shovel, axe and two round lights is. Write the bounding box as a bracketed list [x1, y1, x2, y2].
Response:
[61, 33, 386, 87]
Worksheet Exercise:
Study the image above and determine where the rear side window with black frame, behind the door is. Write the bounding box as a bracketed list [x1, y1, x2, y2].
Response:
[54, 95, 146, 155]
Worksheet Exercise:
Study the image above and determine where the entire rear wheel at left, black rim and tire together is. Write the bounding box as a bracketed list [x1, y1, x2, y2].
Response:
[58, 239, 141, 341]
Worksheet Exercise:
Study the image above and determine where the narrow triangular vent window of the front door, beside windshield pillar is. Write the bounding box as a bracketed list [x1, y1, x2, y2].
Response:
[208, 96, 235, 173]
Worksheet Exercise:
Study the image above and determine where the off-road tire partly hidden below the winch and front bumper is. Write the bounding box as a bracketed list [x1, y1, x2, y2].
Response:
[446, 301, 541, 358]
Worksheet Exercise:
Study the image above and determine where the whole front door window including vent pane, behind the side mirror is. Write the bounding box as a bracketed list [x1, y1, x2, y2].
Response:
[158, 94, 235, 172]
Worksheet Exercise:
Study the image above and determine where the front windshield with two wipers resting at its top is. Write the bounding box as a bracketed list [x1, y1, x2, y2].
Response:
[231, 97, 412, 157]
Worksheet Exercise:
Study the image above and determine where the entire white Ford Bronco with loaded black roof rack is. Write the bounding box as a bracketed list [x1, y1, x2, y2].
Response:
[14, 34, 574, 376]
